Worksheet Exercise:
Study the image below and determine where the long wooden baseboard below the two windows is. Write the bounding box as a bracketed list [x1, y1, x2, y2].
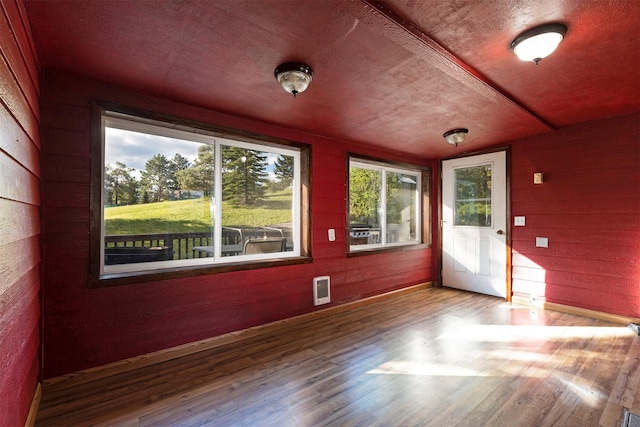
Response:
[43, 282, 433, 386]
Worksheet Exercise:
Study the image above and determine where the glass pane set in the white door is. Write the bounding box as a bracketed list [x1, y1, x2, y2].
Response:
[454, 165, 491, 227]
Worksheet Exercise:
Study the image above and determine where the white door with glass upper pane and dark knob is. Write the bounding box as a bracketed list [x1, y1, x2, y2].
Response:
[442, 151, 507, 298]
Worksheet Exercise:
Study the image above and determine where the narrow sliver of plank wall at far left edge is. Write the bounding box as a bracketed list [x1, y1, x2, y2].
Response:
[0, 0, 40, 426]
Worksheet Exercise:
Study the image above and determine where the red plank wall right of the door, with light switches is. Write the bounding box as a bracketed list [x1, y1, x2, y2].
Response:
[511, 114, 640, 318]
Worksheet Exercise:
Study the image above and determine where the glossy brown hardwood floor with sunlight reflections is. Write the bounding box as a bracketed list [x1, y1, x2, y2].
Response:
[36, 288, 640, 427]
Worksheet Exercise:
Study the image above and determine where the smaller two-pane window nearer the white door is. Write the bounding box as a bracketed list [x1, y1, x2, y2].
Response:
[348, 158, 428, 252]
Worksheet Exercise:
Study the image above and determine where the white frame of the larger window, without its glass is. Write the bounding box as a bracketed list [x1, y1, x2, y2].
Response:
[99, 111, 302, 276]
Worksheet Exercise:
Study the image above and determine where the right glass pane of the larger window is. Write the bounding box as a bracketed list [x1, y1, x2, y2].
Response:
[221, 145, 294, 256]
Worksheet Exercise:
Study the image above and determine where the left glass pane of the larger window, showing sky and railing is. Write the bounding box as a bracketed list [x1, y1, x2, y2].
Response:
[103, 127, 213, 265]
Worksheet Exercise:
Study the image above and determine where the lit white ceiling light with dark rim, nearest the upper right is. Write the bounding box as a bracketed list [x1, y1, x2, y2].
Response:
[510, 24, 567, 65]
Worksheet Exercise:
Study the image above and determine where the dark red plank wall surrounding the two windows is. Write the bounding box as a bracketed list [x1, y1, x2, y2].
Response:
[42, 70, 435, 378]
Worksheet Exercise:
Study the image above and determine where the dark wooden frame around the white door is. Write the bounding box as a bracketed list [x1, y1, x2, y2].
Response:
[436, 149, 512, 302]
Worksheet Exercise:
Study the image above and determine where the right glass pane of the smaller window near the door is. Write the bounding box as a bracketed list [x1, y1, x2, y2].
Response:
[386, 172, 419, 243]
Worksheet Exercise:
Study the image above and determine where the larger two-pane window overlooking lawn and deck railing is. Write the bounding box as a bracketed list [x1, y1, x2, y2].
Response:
[91, 104, 307, 284]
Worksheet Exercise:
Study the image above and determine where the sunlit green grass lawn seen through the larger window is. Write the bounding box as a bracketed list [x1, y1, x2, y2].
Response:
[105, 190, 292, 235]
